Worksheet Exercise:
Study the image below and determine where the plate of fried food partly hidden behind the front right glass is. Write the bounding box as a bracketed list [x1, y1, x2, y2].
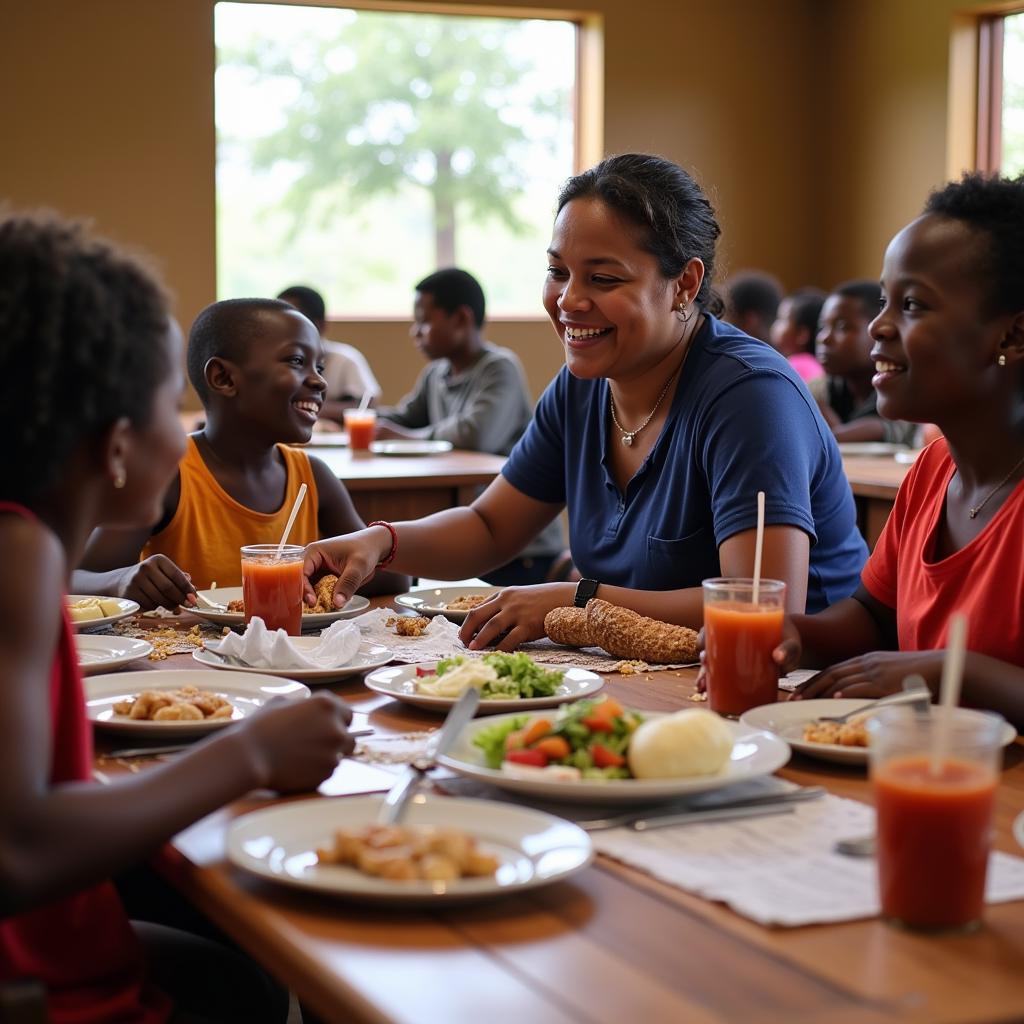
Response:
[739, 697, 1017, 765]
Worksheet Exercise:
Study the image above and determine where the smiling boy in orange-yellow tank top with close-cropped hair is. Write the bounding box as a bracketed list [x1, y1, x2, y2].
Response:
[75, 299, 408, 608]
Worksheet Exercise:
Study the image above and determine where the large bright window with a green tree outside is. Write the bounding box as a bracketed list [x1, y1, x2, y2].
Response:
[215, 2, 580, 316]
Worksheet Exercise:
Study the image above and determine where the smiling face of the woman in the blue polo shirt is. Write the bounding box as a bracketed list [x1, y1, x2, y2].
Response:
[544, 198, 702, 380]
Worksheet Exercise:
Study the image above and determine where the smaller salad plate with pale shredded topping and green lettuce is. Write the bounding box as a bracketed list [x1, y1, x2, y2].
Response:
[366, 651, 604, 714]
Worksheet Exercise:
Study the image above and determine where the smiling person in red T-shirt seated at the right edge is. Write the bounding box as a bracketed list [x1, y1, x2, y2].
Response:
[776, 174, 1024, 729]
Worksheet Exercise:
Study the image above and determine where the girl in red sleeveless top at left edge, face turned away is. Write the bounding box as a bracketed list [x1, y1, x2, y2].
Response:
[0, 211, 352, 1024]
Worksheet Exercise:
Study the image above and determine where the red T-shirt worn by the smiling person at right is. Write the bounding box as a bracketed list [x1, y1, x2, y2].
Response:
[861, 438, 1024, 667]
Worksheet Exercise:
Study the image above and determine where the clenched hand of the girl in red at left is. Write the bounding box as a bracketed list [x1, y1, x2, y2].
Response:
[239, 690, 355, 793]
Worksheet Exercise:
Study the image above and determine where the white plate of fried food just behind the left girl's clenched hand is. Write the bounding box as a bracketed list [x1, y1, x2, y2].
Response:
[84, 669, 309, 738]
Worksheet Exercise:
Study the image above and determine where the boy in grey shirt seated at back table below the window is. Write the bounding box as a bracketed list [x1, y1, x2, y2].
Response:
[377, 267, 564, 587]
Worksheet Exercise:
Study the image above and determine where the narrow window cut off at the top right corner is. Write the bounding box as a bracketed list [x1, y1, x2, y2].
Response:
[976, 11, 1024, 176]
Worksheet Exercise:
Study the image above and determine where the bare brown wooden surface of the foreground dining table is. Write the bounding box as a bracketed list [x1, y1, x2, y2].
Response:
[90, 598, 1024, 1024]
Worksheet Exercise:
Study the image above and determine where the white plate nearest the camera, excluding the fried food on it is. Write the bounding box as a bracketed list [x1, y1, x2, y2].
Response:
[226, 795, 594, 905]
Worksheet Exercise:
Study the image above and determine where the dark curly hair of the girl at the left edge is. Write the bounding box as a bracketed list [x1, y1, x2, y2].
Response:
[0, 212, 172, 501]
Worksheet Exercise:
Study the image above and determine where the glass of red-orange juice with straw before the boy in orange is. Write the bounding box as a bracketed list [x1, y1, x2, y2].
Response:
[242, 483, 306, 636]
